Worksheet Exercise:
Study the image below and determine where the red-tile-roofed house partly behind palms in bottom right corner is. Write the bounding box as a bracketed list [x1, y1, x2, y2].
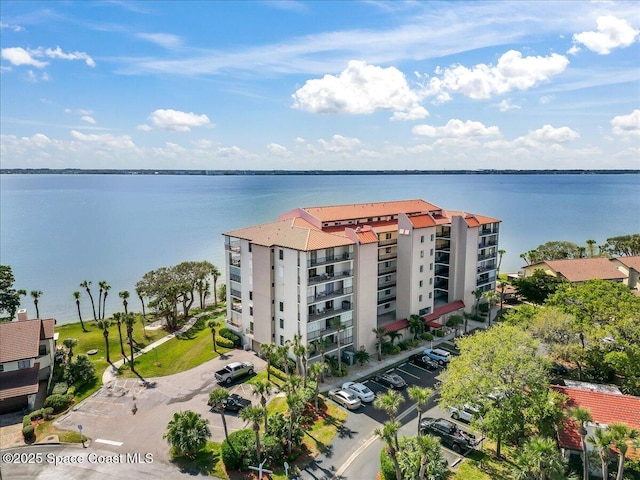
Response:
[551, 381, 640, 476]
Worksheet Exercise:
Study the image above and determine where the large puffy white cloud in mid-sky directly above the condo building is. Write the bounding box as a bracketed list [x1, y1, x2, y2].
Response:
[292, 60, 427, 118]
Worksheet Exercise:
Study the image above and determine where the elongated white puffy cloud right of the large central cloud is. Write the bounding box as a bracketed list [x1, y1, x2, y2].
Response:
[425, 50, 569, 103]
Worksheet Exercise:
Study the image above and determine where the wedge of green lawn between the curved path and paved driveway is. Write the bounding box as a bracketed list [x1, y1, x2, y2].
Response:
[121, 313, 230, 378]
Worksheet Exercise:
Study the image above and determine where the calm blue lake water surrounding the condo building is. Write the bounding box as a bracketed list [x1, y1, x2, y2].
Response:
[0, 175, 640, 323]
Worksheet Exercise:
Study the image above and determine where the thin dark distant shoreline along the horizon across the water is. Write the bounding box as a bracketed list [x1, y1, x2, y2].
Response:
[0, 168, 640, 176]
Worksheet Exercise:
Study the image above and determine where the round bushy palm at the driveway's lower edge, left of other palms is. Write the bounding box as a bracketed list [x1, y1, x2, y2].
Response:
[162, 410, 211, 457]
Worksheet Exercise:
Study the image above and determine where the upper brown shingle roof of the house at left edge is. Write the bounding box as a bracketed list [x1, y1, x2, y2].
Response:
[0, 319, 42, 363]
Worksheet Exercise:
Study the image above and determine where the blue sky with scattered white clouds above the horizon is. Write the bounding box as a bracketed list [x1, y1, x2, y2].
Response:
[0, 0, 640, 170]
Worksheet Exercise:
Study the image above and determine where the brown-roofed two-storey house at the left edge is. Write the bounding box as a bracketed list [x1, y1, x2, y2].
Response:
[0, 312, 57, 413]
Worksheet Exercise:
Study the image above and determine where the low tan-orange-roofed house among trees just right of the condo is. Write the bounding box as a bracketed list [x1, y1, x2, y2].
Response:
[524, 257, 629, 284]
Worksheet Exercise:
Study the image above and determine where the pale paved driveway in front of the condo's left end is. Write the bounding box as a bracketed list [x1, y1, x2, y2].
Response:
[55, 350, 266, 461]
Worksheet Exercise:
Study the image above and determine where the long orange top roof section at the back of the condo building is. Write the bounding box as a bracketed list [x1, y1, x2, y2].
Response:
[303, 199, 439, 222]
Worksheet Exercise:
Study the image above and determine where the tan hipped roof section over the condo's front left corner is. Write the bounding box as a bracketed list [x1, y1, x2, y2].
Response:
[225, 218, 354, 251]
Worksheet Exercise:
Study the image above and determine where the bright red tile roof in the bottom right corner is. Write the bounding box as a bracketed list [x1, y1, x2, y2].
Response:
[551, 385, 640, 450]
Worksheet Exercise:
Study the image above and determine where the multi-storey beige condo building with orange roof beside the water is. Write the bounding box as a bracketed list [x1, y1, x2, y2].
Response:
[223, 200, 500, 358]
